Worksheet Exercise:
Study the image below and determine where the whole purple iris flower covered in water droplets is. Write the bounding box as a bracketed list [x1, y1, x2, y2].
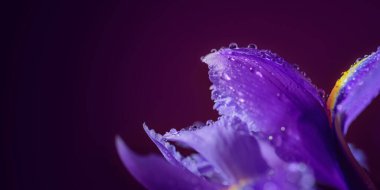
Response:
[116, 45, 380, 190]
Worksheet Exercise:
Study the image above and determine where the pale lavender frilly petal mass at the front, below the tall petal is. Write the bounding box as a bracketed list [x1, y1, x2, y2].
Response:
[146, 116, 315, 190]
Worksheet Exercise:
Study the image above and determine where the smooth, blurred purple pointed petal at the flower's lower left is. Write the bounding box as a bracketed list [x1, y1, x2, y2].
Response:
[116, 137, 217, 190]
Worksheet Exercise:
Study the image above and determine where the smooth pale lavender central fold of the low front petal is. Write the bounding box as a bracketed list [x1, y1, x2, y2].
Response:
[163, 117, 269, 185]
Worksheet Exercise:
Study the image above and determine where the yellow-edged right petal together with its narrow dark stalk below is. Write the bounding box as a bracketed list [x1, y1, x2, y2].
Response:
[327, 48, 380, 189]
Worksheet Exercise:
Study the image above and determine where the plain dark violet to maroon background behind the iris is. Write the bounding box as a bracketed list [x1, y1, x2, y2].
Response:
[0, 0, 380, 190]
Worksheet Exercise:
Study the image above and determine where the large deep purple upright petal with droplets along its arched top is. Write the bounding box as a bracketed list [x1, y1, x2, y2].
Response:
[203, 48, 345, 189]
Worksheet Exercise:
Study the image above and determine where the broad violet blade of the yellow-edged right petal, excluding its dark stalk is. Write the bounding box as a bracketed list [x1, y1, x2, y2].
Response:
[327, 48, 380, 134]
